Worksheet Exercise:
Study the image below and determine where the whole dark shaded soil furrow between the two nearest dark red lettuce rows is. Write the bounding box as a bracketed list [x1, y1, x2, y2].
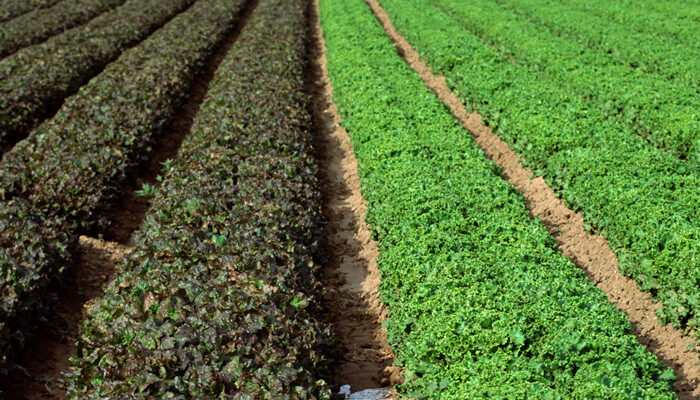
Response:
[2, 0, 258, 400]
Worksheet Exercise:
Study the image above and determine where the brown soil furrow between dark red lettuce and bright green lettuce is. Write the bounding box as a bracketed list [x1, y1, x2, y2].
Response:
[308, 0, 402, 392]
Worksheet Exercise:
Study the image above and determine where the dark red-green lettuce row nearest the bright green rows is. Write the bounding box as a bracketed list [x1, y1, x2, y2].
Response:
[67, 0, 330, 400]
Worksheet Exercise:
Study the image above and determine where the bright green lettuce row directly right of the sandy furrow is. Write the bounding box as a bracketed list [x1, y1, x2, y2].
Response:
[381, 0, 700, 335]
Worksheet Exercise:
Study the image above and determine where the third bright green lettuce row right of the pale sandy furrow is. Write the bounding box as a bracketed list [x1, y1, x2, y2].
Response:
[494, 0, 700, 90]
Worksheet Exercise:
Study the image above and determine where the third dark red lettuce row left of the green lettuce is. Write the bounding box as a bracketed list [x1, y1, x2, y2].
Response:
[0, 0, 195, 151]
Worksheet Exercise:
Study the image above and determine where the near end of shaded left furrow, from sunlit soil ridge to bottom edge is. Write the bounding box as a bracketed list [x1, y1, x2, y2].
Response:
[2, 236, 131, 400]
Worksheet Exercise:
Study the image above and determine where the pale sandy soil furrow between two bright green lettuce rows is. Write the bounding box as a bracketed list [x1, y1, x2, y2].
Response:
[366, 0, 700, 400]
